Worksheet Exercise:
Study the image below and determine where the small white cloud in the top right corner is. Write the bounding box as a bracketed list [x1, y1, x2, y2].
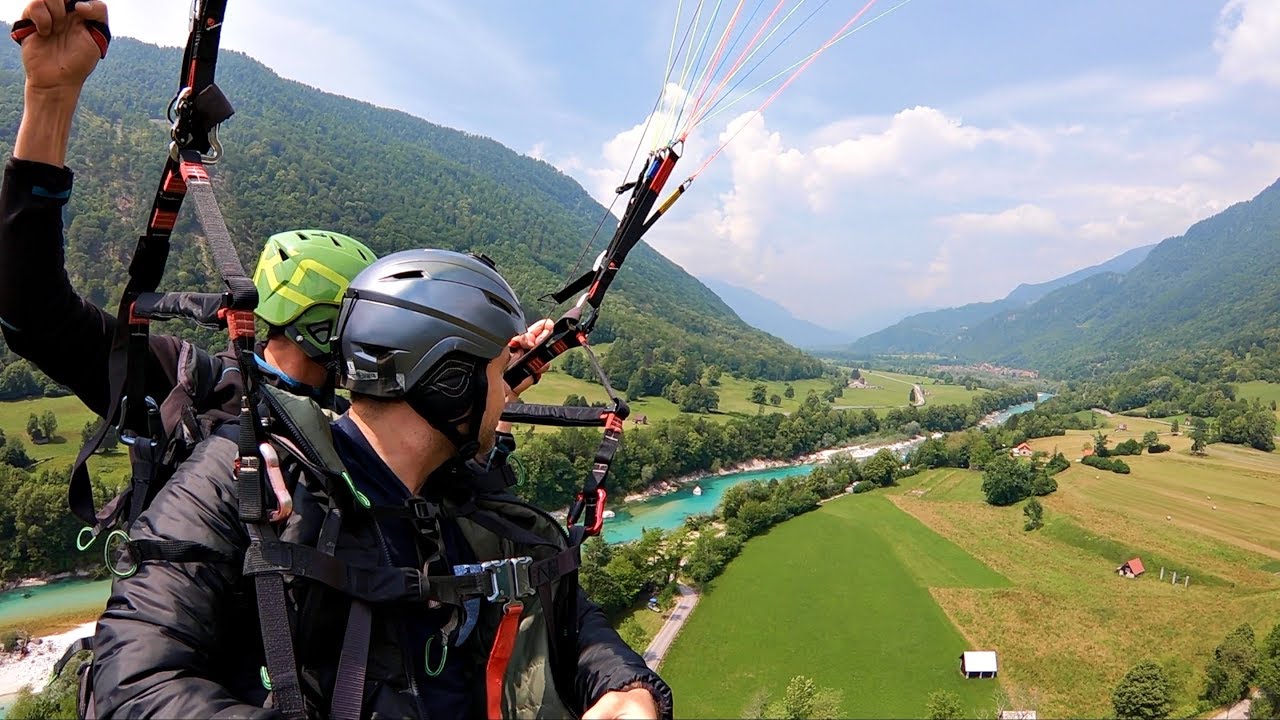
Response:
[1213, 0, 1280, 87]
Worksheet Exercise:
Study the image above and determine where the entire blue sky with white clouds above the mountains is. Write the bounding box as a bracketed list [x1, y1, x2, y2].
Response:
[10, 0, 1280, 328]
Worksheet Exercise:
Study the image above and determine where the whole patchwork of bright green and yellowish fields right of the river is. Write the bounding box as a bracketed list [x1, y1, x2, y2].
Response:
[663, 418, 1280, 717]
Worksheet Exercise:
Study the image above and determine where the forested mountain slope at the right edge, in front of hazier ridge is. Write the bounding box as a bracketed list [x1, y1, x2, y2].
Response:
[954, 182, 1280, 374]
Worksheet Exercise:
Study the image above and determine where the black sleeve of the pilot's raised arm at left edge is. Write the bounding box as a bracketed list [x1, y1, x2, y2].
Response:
[0, 158, 179, 415]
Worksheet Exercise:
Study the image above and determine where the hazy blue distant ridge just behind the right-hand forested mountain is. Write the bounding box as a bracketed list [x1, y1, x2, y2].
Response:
[850, 245, 1155, 355]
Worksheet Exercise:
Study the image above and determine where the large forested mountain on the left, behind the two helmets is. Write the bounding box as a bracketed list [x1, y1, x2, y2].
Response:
[0, 30, 822, 388]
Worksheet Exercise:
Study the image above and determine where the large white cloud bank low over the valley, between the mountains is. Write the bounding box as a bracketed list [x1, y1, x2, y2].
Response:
[570, 92, 1280, 327]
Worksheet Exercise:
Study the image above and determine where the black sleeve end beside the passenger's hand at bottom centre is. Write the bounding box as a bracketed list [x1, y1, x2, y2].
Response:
[577, 588, 673, 720]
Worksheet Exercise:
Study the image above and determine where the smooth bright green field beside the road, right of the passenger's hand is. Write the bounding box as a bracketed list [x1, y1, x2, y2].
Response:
[663, 495, 1009, 717]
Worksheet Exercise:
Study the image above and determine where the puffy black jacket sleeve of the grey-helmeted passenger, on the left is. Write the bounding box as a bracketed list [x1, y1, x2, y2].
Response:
[93, 437, 279, 720]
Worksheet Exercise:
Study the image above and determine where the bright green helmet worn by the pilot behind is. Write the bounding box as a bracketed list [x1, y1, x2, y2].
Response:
[253, 231, 378, 363]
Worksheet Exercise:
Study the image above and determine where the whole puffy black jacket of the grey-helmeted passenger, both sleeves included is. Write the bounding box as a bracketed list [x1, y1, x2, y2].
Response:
[93, 420, 672, 719]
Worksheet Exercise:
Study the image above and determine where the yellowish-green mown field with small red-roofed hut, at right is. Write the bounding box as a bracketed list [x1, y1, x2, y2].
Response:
[891, 418, 1280, 717]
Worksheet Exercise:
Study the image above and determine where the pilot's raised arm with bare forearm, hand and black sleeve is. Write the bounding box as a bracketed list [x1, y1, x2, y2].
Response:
[0, 0, 185, 415]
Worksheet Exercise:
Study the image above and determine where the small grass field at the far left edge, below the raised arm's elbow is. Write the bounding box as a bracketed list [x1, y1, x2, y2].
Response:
[0, 396, 129, 482]
